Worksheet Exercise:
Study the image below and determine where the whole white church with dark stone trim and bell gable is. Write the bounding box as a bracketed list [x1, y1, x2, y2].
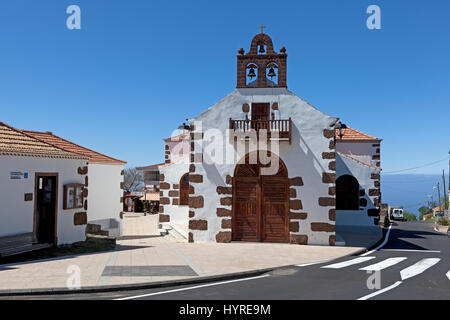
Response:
[153, 33, 381, 245]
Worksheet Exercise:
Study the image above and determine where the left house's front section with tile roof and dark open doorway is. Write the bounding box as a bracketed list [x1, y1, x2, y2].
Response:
[0, 122, 89, 245]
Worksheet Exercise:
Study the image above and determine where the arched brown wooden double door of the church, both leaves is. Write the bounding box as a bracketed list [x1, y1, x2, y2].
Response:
[232, 159, 289, 242]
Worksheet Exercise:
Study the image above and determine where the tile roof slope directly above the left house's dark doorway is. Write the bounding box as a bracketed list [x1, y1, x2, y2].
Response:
[0, 122, 86, 159]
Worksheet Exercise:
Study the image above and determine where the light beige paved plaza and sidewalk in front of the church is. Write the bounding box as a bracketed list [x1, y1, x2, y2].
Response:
[0, 214, 363, 290]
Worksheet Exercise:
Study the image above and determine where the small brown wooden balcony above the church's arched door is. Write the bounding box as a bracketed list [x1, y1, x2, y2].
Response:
[230, 118, 292, 143]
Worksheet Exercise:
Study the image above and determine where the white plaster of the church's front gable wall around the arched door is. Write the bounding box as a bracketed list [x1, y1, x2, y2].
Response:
[190, 88, 337, 245]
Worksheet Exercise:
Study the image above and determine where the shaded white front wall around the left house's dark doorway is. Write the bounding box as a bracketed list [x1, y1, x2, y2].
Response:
[0, 156, 87, 245]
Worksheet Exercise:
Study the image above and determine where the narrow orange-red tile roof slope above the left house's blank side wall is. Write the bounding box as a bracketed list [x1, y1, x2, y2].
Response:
[22, 130, 126, 164]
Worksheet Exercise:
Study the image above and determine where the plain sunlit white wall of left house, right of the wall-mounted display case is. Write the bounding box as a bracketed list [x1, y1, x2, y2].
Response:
[88, 163, 124, 236]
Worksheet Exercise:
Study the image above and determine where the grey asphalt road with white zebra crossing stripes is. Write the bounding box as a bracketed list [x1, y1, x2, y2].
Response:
[1, 222, 450, 300]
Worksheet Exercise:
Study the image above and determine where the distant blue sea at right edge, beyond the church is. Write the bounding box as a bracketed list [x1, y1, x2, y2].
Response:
[381, 172, 448, 215]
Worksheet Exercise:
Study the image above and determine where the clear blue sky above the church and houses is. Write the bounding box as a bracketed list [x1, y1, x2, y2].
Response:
[0, 0, 450, 178]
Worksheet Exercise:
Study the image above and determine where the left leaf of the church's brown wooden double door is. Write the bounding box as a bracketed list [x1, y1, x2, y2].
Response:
[232, 177, 261, 241]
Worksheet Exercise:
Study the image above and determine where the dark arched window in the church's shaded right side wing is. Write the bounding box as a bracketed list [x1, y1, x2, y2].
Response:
[336, 175, 359, 210]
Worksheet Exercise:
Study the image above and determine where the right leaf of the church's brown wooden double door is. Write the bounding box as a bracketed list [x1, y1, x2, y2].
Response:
[261, 176, 289, 242]
